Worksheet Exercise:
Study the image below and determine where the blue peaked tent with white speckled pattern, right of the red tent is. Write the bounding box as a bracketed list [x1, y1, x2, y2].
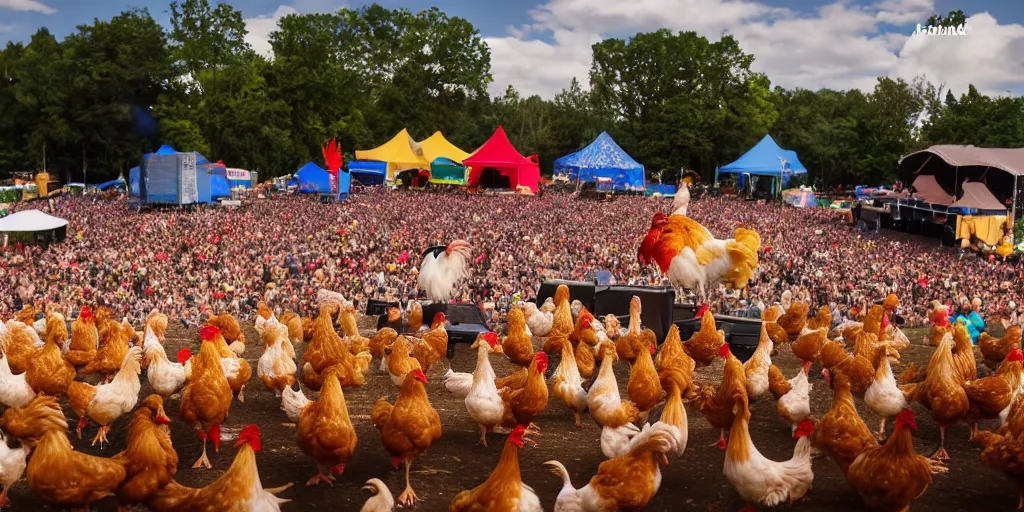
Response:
[555, 132, 645, 190]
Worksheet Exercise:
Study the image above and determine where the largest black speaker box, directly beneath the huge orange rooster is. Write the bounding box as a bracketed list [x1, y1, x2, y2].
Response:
[591, 286, 676, 343]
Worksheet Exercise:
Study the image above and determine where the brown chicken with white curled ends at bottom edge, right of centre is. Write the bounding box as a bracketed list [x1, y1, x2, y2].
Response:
[545, 423, 679, 512]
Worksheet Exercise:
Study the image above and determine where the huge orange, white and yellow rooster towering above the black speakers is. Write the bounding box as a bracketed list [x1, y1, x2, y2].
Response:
[638, 183, 761, 302]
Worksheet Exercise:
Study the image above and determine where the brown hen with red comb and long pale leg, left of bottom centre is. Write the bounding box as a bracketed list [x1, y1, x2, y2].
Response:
[370, 369, 441, 506]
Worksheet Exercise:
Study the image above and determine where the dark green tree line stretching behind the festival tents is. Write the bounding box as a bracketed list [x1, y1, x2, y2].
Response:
[0, 0, 1024, 186]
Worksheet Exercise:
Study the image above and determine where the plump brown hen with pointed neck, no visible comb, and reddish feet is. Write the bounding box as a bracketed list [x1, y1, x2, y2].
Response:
[297, 367, 356, 486]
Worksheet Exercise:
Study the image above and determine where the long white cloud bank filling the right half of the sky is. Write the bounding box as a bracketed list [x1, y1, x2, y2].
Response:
[486, 0, 1024, 98]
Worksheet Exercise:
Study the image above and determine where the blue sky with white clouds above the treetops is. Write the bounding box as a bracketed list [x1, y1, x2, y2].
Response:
[0, 0, 1024, 98]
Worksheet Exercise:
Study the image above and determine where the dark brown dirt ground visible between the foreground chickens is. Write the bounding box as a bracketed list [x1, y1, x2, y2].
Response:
[10, 325, 1018, 511]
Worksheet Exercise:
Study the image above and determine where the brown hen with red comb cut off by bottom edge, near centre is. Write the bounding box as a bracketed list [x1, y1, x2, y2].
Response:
[449, 425, 544, 512]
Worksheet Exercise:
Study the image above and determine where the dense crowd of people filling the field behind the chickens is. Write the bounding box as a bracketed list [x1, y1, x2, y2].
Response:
[0, 188, 1024, 326]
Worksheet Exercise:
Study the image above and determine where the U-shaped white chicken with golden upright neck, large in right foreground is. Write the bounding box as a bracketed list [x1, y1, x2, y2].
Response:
[724, 387, 814, 507]
